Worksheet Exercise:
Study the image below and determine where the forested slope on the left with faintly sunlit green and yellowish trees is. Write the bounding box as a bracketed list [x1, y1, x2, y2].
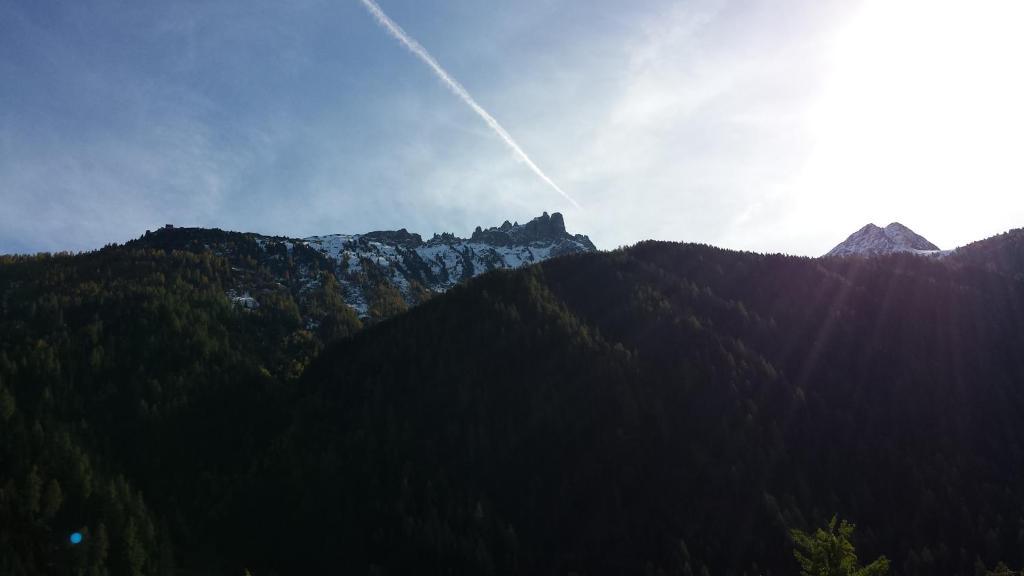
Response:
[0, 247, 333, 575]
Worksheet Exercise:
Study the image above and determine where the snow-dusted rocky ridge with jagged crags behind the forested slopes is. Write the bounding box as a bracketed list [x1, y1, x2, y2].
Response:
[129, 212, 596, 319]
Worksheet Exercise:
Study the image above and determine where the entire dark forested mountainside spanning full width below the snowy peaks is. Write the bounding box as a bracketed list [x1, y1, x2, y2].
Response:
[0, 226, 1024, 576]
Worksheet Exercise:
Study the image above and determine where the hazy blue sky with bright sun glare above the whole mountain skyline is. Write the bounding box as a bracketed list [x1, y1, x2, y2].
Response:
[0, 0, 1024, 255]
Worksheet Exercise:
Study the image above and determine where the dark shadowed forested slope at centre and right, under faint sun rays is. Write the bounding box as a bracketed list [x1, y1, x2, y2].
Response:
[245, 236, 1024, 574]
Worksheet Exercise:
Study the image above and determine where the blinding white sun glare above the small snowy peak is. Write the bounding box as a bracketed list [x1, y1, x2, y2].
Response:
[800, 0, 1024, 240]
